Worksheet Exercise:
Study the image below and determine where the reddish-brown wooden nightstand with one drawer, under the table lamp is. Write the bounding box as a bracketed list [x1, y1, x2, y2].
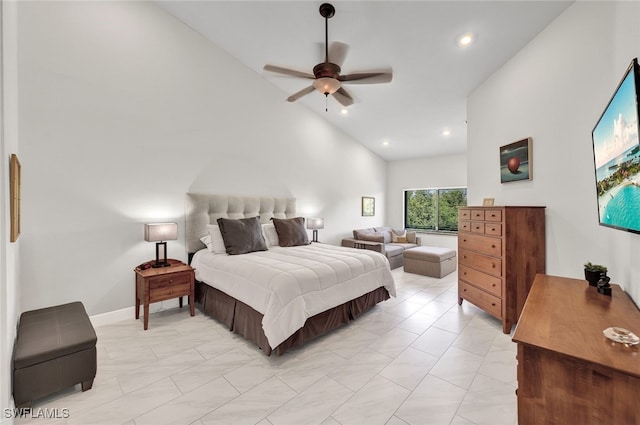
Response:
[134, 260, 195, 331]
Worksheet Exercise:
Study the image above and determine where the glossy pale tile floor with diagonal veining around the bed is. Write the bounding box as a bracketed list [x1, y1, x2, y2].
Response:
[15, 268, 517, 425]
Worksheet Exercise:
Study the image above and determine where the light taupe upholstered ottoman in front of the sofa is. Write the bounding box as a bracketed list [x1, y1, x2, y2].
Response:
[402, 246, 458, 278]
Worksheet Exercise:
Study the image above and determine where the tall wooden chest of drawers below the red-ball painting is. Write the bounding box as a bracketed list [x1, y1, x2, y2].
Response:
[458, 206, 545, 333]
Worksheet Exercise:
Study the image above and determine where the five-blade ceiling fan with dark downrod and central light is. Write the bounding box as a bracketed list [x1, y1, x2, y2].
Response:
[264, 3, 393, 106]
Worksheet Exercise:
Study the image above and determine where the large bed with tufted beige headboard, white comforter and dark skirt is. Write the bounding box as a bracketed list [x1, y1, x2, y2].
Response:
[186, 194, 395, 355]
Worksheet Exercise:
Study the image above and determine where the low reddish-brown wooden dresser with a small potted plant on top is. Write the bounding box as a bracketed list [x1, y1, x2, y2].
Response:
[513, 275, 640, 425]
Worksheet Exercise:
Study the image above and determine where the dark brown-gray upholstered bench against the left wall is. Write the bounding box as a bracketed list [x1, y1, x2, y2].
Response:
[13, 302, 98, 407]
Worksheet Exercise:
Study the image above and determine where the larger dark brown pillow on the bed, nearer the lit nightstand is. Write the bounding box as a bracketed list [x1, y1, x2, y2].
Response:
[218, 217, 268, 255]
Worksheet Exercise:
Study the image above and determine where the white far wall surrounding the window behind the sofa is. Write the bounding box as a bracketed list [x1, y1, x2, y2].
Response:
[386, 154, 467, 250]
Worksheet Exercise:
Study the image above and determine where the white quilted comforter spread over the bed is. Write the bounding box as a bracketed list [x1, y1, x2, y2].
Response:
[191, 243, 396, 348]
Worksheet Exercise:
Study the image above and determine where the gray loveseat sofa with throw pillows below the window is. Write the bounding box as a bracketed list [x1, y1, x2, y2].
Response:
[342, 227, 420, 269]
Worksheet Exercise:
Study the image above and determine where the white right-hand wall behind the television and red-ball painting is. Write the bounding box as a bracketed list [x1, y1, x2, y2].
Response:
[467, 2, 640, 303]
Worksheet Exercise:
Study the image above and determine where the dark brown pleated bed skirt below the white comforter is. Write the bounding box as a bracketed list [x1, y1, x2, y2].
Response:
[195, 281, 389, 356]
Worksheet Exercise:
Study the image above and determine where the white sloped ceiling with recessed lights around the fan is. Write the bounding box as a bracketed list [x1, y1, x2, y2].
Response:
[158, 0, 571, 160]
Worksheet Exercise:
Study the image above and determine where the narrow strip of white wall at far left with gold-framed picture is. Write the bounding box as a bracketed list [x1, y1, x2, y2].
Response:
[0, 1, 21, 425]
